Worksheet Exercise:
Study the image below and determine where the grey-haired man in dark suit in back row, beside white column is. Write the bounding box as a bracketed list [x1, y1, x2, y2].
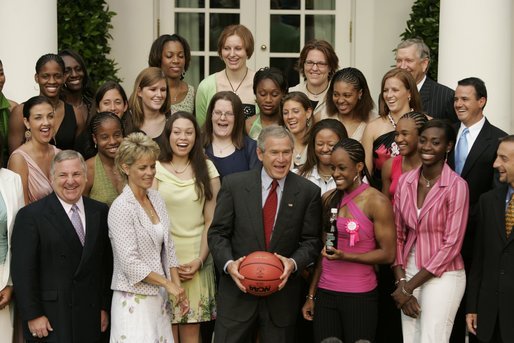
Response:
[396, 38, 458, 123]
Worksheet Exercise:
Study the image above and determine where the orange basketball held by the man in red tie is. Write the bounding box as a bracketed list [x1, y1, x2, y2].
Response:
[239, 251, 284, 296]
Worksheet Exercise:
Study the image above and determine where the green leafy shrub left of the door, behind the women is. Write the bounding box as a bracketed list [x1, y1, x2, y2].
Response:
[57, 0, 120, 89]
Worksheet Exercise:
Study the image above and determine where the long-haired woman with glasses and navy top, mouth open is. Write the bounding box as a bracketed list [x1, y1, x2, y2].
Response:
[203, 91, 261, 179]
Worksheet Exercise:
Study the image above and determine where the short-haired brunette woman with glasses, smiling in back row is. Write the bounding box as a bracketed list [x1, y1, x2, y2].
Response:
[289, 39, 339, 121]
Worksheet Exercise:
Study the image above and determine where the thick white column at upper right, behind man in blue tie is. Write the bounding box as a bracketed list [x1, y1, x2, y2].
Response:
[438, 0, 514, 132]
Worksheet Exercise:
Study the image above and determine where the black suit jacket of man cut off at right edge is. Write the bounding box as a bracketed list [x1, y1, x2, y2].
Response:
[467, 186, 514, 342]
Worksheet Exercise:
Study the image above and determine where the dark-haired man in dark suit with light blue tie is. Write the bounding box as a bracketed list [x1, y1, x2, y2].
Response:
[448, 77, 507, 343]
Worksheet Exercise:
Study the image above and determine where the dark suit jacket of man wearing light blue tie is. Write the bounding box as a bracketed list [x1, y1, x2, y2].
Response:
[448, 119, 507, 262]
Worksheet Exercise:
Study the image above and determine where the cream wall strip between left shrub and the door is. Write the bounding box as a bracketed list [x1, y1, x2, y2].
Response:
[107, 0, 155, 96]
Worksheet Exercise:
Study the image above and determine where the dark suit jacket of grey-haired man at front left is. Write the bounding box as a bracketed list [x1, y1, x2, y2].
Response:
[11, 193, 112, 343]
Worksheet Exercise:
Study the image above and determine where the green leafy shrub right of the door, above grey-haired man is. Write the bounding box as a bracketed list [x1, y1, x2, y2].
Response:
[400, 0, 439, 80]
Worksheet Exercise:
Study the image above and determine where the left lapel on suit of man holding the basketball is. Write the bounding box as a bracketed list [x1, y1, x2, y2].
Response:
[245, 173, 266, 251]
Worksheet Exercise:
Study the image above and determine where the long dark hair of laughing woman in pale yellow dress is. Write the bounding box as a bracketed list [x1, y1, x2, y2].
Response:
[159, 111, 213, 200]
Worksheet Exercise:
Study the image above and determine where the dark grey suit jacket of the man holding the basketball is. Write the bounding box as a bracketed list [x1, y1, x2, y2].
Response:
[208, 170, 322, 327]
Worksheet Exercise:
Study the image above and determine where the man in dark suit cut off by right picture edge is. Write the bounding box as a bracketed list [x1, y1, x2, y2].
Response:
[466, 135, 514, 343]
